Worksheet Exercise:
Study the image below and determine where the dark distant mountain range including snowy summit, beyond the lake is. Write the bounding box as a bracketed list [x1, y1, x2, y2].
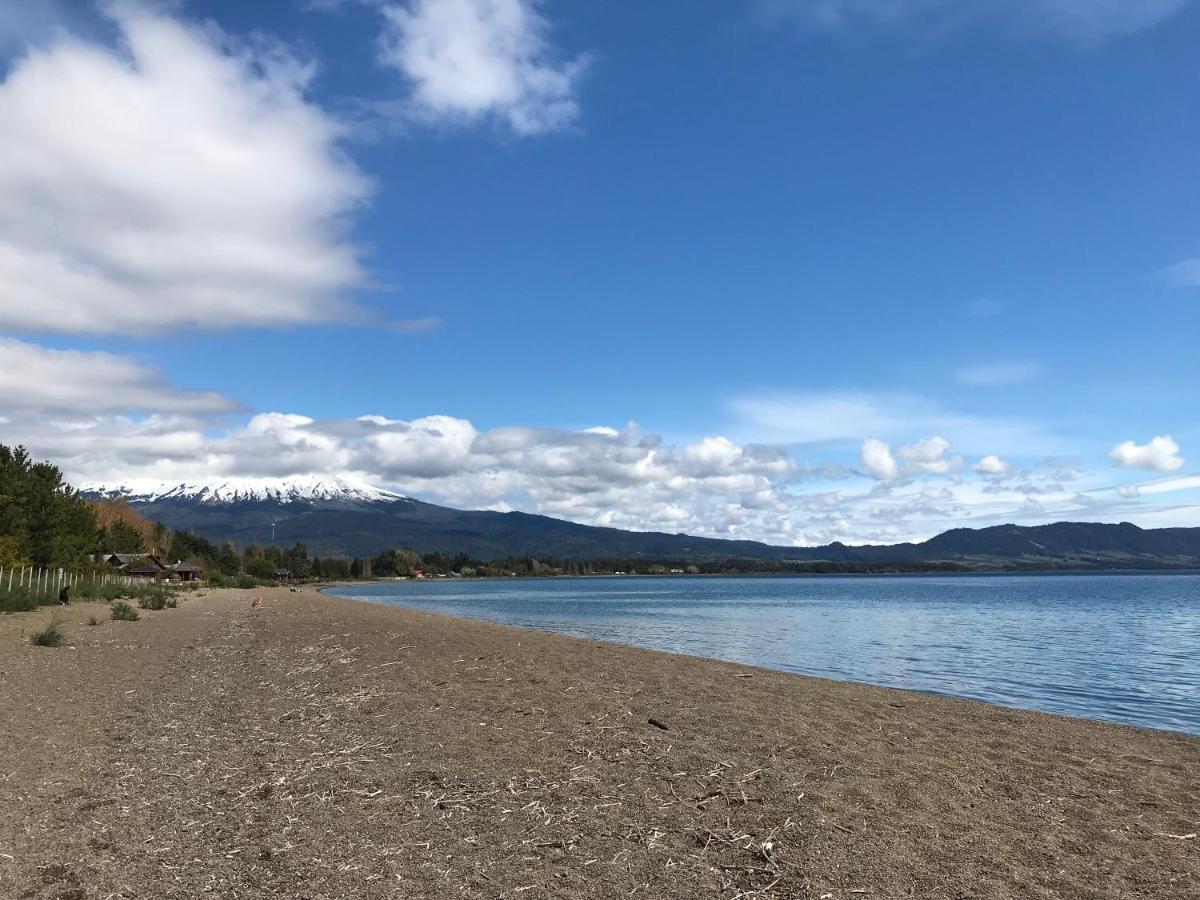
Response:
[82, 478, 1200, 569]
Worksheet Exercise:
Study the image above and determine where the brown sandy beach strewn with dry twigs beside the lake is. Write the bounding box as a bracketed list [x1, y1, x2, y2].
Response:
[0, 588, 1200, 900]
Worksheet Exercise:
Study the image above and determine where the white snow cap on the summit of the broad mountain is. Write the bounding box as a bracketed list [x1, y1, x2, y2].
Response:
[80, 475, 409, 505]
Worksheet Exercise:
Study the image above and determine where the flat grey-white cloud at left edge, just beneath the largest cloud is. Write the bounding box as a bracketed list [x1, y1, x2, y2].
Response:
[0, 337, 236, 415]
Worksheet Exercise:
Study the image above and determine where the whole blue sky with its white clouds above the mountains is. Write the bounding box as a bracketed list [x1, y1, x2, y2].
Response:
[0, 0, 1200, 544]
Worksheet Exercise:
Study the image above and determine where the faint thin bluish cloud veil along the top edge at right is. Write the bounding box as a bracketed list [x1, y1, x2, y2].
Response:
[766, 0, 1188, 46]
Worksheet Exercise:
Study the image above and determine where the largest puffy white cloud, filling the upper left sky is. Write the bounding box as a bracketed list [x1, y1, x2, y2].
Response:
[0, 2, 370, 334]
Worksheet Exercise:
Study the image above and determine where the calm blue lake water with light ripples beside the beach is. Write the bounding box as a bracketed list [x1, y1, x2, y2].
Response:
[324, 575, 1200, 734]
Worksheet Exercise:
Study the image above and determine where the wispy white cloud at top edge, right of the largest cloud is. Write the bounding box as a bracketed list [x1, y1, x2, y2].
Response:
[379, 0, 587, 136]
